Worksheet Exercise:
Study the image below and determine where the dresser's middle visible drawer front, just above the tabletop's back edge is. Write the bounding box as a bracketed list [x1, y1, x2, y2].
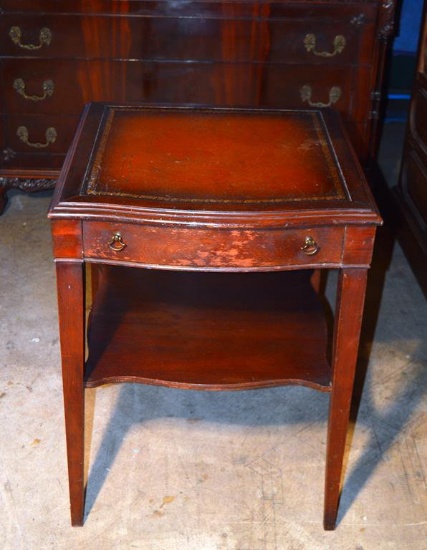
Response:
[3, 59, 364, 114]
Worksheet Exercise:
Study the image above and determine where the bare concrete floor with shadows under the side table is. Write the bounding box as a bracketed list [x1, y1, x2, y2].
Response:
[0, 126, 427, 550]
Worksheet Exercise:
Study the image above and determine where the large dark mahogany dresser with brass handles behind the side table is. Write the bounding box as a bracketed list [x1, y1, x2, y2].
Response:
[0, 0, 395, 213]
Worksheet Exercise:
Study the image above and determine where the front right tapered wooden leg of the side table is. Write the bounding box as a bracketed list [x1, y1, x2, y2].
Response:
[324, 269, 367, 530]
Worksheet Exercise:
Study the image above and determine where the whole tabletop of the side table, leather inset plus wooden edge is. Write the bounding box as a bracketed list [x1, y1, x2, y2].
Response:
[50, 103, 380, 225]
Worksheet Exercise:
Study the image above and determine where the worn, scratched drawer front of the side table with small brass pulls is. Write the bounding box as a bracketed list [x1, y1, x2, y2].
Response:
[83, 222, 344, 270]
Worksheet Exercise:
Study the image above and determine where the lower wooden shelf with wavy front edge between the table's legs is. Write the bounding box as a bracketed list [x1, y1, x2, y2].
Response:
[85, 265, 331, 391]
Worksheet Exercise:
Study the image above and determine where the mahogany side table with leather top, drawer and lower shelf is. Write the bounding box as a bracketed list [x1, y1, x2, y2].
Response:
[49, 103, 381, 529]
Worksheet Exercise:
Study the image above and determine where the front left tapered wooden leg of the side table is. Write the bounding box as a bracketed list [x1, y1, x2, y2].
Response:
[56, 261, 85, 525]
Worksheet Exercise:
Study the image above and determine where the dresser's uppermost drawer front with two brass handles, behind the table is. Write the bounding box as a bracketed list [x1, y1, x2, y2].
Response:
[0, 3, 377, 65]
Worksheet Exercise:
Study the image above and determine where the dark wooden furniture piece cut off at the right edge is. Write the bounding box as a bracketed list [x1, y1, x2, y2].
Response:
[395, 3, 427, 295]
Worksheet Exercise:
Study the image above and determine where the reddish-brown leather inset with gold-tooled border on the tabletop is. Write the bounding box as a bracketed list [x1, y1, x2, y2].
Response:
[85, 109, 347, 209]
